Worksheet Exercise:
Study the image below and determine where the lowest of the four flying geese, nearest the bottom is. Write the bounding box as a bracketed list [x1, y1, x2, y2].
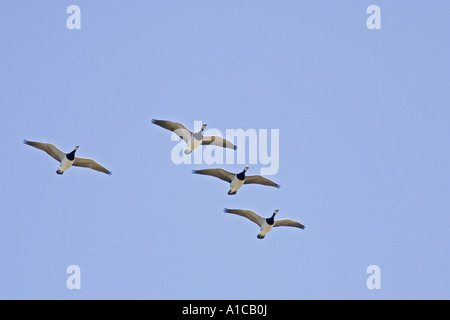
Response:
[224, 209, 305, 239]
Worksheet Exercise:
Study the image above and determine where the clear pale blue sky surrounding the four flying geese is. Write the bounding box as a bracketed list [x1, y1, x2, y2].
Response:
[0, 0, 450, 299]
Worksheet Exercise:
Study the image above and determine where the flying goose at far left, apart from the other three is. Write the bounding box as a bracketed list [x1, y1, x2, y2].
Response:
[23, 140, 112, 175]
